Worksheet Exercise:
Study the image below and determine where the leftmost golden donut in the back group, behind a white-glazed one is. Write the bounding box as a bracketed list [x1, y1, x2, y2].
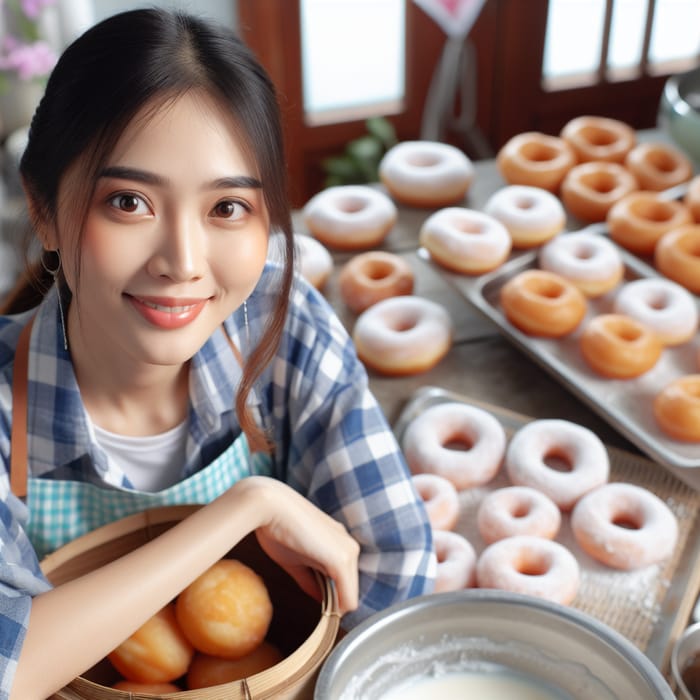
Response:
[496, 131, 576, 192]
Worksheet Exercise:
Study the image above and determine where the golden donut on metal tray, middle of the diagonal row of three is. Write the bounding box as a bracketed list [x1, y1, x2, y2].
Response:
[579, 314, 663, 379]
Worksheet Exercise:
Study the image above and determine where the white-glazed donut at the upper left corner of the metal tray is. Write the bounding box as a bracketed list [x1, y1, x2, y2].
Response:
[418, 207, 511, 275]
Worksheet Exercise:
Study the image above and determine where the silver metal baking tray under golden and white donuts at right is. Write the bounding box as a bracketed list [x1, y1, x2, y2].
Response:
[422, 249, 700, 476]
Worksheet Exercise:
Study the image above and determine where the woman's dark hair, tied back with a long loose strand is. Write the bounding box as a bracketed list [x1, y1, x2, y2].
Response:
[5, 9, 294, 447]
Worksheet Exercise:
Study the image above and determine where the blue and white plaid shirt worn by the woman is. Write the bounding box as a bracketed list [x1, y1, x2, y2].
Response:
[0, 265, 435, 698]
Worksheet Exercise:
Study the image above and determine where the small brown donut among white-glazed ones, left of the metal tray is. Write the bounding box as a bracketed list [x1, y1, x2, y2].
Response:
[338, 250, 414, 313]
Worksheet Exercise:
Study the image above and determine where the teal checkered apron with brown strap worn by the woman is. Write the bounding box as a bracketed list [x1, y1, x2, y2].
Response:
[10, 324, 272, 559]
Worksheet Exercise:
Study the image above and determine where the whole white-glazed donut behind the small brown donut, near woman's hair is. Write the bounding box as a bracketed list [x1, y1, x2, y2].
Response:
[302, 185, 398, 250]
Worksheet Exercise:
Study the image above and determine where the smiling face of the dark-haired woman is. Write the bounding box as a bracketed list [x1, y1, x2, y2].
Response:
[56, 94, 269, 372]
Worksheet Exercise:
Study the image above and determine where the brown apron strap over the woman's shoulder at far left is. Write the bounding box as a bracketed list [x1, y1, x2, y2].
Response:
[10, 318, 34, 498]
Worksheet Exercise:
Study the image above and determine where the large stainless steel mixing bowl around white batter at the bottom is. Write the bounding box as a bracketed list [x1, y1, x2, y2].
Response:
[314, 589, 675, 700]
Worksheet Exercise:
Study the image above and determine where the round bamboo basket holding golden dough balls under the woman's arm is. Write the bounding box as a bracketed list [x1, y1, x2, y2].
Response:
[41, 506, 340, 700]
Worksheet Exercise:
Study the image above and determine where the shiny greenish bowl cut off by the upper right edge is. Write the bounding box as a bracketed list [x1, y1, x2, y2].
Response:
[658, 68, 700, 164]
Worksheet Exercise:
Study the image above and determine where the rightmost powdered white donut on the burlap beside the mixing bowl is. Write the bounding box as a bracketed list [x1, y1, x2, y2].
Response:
[571, 483, 678, 571]
